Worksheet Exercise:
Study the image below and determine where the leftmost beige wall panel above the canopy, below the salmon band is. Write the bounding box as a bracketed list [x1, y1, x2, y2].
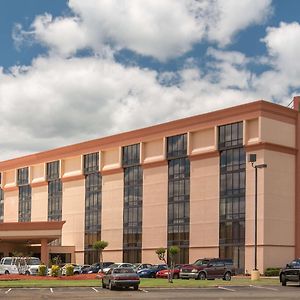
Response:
[4, 189, 19, 222]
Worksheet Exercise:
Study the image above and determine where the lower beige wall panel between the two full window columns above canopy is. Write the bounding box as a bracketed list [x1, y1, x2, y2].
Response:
[31, 185, 48, 222]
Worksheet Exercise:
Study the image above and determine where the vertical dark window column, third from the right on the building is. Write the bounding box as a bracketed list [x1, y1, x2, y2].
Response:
[122, 144, 143, 263]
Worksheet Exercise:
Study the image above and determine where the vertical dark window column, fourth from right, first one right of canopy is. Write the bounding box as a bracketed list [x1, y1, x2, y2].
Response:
[83, 152, 102, 264]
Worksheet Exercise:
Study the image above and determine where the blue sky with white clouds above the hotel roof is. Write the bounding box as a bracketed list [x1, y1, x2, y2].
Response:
[0, 0, 300, 161]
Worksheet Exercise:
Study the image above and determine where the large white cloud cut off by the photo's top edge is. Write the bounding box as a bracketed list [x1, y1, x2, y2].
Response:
[15, 0, 271, 61]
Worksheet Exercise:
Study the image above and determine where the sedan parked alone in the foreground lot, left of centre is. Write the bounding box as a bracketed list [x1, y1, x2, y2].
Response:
[102, 267, 140, 290]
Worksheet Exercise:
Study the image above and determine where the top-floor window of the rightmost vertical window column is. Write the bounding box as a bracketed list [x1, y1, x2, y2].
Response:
[219, 122, 243, 149]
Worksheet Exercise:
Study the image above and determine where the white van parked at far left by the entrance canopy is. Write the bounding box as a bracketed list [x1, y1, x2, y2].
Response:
[0, 257, 41, 275]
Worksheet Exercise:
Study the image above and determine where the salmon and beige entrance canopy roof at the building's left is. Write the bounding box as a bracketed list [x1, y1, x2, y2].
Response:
[0, 221, 66, 244]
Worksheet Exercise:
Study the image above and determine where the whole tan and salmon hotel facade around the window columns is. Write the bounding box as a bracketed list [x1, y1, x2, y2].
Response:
[0, 99, 300, 273]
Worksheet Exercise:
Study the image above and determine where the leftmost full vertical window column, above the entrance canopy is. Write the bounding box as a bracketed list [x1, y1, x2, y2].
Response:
[17, 167, 31, 222]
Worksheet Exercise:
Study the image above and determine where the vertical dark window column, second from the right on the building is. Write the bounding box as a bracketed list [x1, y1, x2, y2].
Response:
[167, 134, 190, 264]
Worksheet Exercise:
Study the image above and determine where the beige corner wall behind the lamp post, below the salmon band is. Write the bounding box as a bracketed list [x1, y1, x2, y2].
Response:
[245, 150, 295, 272]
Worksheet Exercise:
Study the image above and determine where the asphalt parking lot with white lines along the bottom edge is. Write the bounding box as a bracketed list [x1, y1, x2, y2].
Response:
[0, 285, 300, 300]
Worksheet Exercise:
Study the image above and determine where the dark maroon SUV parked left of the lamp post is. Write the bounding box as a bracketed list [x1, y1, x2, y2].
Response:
[179, 258, 235, 281]
